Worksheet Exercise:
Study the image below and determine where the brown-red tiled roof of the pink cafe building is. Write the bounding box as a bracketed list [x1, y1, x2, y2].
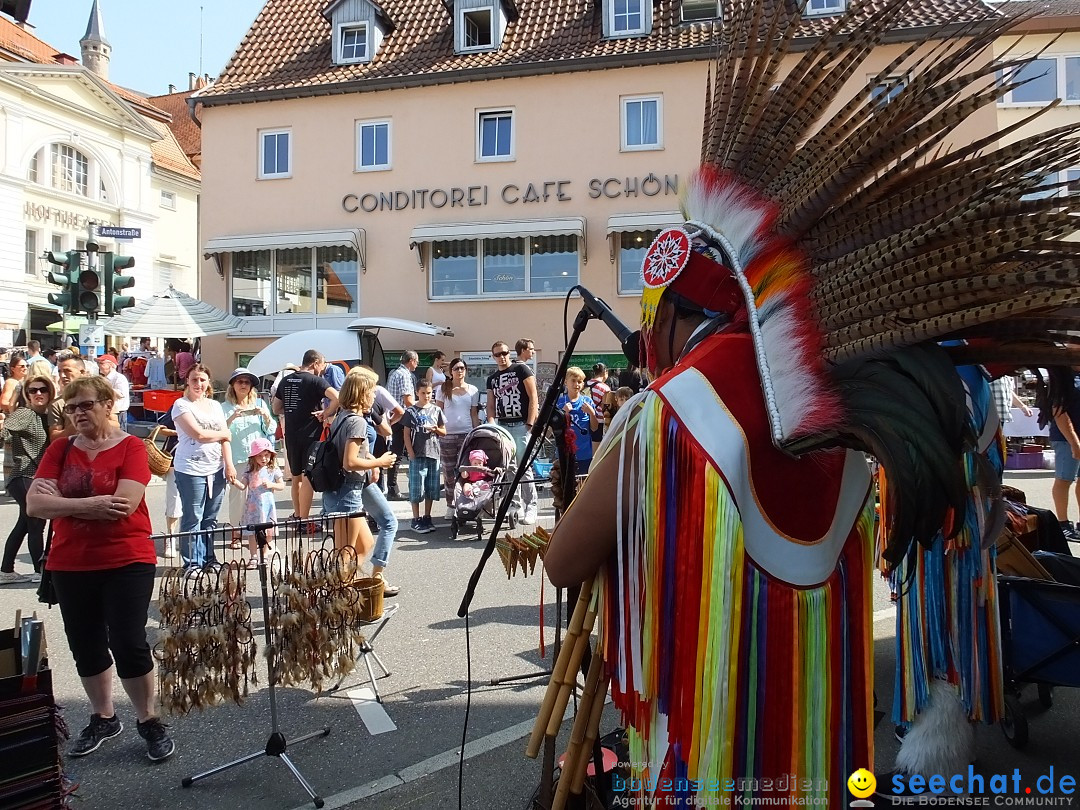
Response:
[200, 0, 993, 106]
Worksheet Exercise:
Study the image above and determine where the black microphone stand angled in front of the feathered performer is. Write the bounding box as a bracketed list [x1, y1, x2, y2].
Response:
[458, 286, 617, 808]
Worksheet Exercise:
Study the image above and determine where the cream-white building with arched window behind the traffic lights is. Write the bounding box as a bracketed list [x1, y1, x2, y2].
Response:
[0, 3, 200, 346]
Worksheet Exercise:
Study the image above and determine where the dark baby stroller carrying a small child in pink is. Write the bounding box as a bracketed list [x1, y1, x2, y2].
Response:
[450, 424, 517, 540]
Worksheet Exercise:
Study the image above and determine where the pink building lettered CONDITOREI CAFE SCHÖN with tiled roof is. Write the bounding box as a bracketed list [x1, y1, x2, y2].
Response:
[195, 0, 994, 380]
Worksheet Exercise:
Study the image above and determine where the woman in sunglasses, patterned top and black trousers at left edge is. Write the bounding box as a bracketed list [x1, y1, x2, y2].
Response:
[0, 377, 56, 585]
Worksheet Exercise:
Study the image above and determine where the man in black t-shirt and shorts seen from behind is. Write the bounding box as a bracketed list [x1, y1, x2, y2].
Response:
[272, 349, 338, 517]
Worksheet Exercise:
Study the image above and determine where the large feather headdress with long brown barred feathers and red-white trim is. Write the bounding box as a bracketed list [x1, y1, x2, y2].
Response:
[643, 0, 1080, 558]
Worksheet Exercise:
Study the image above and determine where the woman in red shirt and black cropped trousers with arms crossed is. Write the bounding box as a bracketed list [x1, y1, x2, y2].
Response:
[26, 377, 175, 761]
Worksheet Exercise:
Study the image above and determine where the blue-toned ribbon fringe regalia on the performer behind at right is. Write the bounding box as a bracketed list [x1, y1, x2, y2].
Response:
[882, 366, 1004, 724]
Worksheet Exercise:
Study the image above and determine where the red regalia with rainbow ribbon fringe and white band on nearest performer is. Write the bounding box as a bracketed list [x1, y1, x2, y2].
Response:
[599, 333, 873, 807]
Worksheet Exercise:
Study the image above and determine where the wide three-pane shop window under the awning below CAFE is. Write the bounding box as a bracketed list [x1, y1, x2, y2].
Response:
[431, 235, 580, 299]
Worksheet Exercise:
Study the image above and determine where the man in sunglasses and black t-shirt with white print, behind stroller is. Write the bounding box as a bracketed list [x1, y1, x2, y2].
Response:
[487, 339, 540, 523]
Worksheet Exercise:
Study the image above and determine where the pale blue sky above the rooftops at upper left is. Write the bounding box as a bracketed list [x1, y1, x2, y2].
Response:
[27, 0, 265, 95]
